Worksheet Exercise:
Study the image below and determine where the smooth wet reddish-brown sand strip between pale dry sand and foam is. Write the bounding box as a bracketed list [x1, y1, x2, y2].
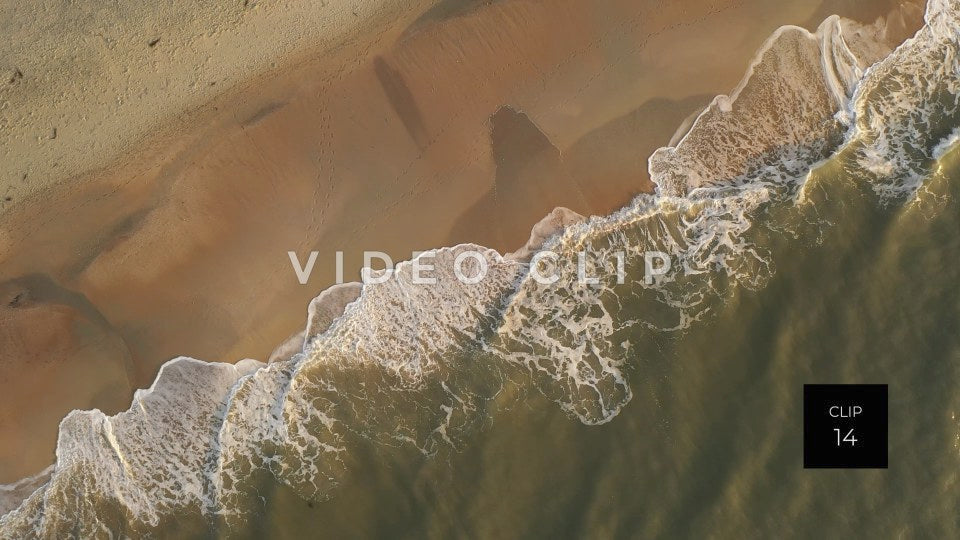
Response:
[0, 2, 924, 486]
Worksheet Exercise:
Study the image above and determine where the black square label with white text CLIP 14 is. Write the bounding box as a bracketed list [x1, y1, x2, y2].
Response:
[803, 384, 887, 469]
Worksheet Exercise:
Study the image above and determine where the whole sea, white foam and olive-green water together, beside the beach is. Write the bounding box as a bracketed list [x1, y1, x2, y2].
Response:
[0, 0, 960, 538]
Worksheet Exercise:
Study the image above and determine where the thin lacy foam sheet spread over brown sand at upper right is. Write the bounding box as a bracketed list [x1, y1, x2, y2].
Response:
[649, 17, 882, 196]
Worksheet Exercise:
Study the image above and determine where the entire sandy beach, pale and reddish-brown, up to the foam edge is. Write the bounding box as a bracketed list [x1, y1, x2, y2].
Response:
[0, 0, 918, 482]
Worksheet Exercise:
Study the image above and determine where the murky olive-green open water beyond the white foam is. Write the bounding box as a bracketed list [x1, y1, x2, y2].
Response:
[204, 152, 960, 538]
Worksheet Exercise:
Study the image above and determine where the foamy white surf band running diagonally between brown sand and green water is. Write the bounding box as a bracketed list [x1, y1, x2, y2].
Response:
[0, 0, 960, 538]
